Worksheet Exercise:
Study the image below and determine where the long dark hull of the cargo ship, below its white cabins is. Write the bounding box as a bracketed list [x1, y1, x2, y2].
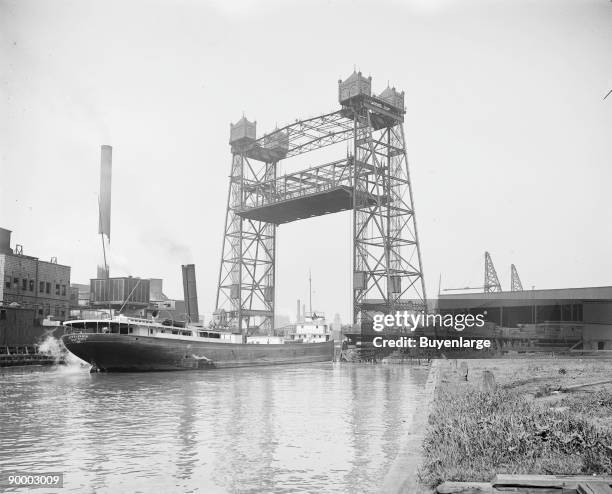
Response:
[62, 333, 334, 372]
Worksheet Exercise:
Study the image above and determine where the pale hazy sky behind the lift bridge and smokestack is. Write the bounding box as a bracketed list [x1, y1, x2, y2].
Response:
[0, 0, 612, 322]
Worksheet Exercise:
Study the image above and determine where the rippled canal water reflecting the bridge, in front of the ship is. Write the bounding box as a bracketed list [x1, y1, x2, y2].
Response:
[0, 363, 427, 494]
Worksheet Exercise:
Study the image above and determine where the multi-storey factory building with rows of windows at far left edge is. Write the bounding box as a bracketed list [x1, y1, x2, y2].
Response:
[0, 228, 70, 319]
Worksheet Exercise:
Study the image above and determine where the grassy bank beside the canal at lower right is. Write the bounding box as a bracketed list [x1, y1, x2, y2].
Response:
[420, 359, 612, 486]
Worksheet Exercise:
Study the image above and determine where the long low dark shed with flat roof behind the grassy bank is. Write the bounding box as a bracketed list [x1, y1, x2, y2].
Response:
[438, 286, 612, 351]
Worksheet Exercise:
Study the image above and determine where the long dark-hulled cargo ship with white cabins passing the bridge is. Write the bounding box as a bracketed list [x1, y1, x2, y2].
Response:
[61, 315, 334, 372]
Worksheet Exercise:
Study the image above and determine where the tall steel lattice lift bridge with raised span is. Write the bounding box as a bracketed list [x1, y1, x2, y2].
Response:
[215, 72, 426, 334]
